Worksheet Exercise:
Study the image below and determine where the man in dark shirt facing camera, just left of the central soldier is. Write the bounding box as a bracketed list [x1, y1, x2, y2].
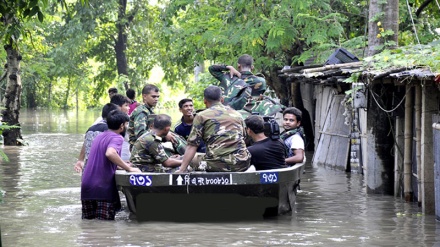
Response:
[174, 98, 206, 153]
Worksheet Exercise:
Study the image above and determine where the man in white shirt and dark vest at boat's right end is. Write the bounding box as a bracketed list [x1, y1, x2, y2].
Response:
[280, 107, 305, 166]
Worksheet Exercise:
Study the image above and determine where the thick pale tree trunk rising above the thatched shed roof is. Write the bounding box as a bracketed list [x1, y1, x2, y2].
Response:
[367, 0, 399, 56]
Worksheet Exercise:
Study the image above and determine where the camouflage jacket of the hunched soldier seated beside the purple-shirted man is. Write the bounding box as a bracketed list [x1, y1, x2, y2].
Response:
[130, 132, 169, 172]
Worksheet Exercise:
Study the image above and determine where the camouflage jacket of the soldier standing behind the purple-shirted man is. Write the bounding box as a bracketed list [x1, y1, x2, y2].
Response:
[127, 104, 154, 147]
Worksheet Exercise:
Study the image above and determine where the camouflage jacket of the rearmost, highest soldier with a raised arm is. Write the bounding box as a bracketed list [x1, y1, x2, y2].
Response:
[209, 65, 266, 97]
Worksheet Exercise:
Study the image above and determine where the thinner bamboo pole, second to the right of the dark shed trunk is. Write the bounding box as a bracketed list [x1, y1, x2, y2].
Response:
[414, 84, 423, 205]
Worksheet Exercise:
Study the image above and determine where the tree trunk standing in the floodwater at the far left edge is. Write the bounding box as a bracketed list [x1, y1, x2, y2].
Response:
[2, 43, 23, 146]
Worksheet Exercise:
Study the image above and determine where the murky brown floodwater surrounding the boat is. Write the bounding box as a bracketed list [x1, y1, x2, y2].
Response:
[0, 111, 440, 246]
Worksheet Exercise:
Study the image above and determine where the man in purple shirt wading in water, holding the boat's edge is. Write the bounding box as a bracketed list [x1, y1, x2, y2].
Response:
[81, 110, 140, 220]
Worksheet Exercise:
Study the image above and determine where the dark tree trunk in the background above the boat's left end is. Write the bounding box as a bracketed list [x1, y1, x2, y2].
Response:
[115, 0, 130, 90]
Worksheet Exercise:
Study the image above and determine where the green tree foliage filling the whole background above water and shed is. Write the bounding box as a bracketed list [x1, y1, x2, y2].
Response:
[0, 0, 440, 108]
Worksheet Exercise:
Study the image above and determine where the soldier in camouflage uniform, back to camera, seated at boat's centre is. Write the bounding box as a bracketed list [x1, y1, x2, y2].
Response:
[179, 86, 250, 172]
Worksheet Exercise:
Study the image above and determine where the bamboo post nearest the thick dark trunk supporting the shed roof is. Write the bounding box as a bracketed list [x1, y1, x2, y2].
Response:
[403, 84, 413, 202]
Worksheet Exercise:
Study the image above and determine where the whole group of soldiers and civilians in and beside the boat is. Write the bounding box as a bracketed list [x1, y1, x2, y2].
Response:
[74, 55, 305, 219]
